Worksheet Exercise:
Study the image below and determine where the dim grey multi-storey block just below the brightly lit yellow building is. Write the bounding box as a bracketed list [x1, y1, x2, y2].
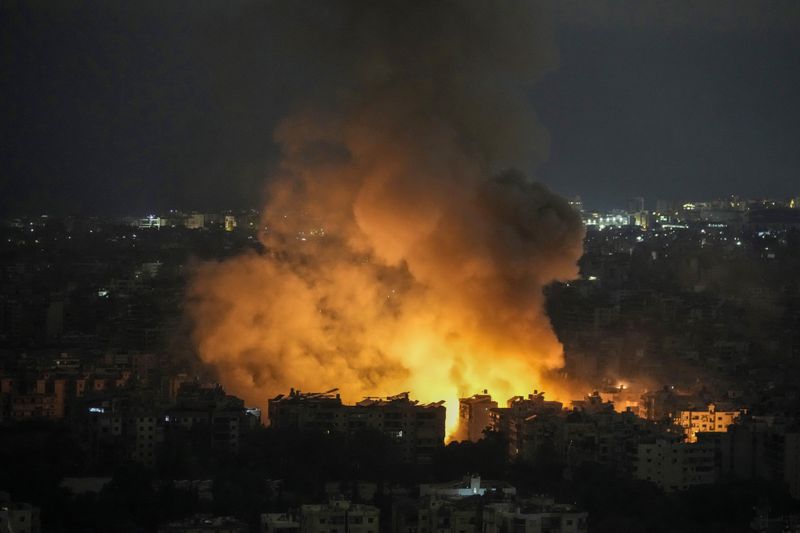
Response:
[633, 439, 716, 492]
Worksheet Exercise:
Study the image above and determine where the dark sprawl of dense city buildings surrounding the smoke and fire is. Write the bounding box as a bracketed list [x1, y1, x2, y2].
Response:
[0, 198, 800, 533]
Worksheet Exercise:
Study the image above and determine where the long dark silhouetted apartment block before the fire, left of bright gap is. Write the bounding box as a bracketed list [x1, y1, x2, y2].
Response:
[268, 389, 445, 464]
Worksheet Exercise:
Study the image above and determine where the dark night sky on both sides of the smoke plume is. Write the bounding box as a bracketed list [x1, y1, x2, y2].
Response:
[0, 0, 800, 214]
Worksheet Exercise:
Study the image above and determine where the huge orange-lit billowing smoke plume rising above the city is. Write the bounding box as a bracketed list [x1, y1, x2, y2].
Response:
[189, 0, 583, 432]
